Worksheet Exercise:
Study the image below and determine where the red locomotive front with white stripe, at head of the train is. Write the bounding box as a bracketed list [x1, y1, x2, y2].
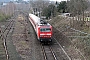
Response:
[38, 20, 52, 41]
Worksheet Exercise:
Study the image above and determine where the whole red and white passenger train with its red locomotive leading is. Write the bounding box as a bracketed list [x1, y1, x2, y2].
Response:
[29, 13, 52, 42]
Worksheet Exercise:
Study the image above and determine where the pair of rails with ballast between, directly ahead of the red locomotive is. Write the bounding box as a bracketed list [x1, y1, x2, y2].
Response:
[41, 44, 57, 60]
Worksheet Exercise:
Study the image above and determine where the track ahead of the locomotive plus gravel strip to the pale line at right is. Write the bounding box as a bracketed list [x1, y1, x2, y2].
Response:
[41, 38, 72, 60]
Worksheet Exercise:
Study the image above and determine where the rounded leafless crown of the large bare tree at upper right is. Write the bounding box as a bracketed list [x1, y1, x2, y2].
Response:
[67, 0, 88, 18]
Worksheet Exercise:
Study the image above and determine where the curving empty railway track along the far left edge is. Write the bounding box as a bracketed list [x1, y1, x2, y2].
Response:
[1, 20, 14, 60]
